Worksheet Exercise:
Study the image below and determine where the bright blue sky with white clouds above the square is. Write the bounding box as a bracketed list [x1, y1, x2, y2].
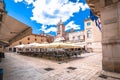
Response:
[4, 0, 89, 36]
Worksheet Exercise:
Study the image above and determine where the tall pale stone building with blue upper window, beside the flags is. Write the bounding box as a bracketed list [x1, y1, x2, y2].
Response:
[84, 19, 102, 52]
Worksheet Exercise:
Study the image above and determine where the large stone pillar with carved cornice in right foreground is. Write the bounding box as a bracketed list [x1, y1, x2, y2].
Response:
[86, 0, 120, 73]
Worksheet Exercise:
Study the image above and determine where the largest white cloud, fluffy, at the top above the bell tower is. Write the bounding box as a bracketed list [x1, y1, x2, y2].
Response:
[14, 0, 89, 25]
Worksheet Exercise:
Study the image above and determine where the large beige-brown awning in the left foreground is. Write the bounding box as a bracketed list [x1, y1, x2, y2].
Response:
[0, 14, 32, 44]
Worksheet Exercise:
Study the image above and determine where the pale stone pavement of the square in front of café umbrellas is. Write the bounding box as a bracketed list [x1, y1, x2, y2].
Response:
[0, 53, 119, 80]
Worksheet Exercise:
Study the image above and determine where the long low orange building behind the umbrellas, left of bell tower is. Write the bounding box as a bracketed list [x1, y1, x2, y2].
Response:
[7, 34, 51, 52]
